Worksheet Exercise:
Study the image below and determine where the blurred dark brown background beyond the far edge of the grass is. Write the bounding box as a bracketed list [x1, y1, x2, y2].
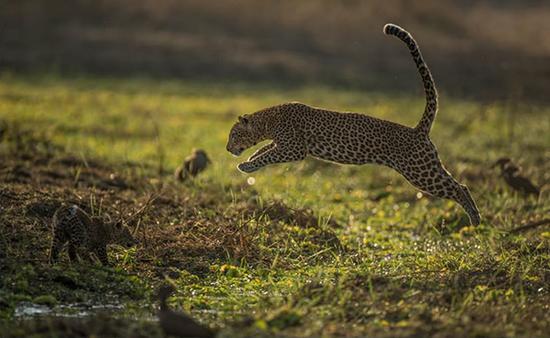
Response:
[0, 0, 550, 102]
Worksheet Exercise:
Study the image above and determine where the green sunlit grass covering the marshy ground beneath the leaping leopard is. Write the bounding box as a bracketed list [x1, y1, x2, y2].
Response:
[0, 74, 550, 337]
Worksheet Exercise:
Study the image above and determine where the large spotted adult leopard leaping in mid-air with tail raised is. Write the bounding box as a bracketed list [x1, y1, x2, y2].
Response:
[226, 24, 480, 225]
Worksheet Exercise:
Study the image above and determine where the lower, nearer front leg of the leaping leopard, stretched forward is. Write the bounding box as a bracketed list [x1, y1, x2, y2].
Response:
[238, 143, 307, 173]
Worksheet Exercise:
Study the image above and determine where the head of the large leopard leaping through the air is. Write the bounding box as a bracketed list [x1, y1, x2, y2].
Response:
[226, 115, 265, 156]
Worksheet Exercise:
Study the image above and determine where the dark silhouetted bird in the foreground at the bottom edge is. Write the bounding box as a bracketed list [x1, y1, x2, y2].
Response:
[158, 285, 216, 338]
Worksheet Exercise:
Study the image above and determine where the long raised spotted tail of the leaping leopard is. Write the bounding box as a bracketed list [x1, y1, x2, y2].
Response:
[384, 23, 438, 135]
